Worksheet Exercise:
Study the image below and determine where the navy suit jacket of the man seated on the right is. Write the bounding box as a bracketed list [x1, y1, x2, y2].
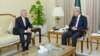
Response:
[69, 15, 88, 32]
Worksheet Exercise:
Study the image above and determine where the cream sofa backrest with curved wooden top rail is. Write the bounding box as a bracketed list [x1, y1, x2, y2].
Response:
[0, 14, 16, 34]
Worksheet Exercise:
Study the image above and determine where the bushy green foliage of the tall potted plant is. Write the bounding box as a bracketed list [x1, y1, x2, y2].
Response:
[30, 0, 46, 26]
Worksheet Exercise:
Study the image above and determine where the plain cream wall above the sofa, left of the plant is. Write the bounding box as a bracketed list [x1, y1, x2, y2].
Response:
[0, 0, 35, 16]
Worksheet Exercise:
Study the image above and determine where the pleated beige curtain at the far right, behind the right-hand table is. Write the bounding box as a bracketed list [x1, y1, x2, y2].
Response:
[87, 0, 100, 33]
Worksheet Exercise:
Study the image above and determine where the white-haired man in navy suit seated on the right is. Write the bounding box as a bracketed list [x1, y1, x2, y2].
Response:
[62, 7, 87, 47]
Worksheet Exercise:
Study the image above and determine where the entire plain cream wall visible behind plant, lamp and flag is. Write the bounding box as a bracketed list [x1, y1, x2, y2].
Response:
[0, 0, 86, 29]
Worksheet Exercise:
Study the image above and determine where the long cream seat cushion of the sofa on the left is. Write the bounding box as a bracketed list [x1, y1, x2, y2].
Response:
[0, 34, 19, 47]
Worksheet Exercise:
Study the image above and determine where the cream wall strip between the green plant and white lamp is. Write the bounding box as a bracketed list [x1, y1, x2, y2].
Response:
[41, 0, 56, 29]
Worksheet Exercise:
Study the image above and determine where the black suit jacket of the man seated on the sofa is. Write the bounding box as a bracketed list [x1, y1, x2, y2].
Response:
[13, 16, 32, 35]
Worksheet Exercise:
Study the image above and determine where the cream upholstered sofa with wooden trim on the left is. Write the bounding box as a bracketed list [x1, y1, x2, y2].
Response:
[0, 14, 19, 53]
